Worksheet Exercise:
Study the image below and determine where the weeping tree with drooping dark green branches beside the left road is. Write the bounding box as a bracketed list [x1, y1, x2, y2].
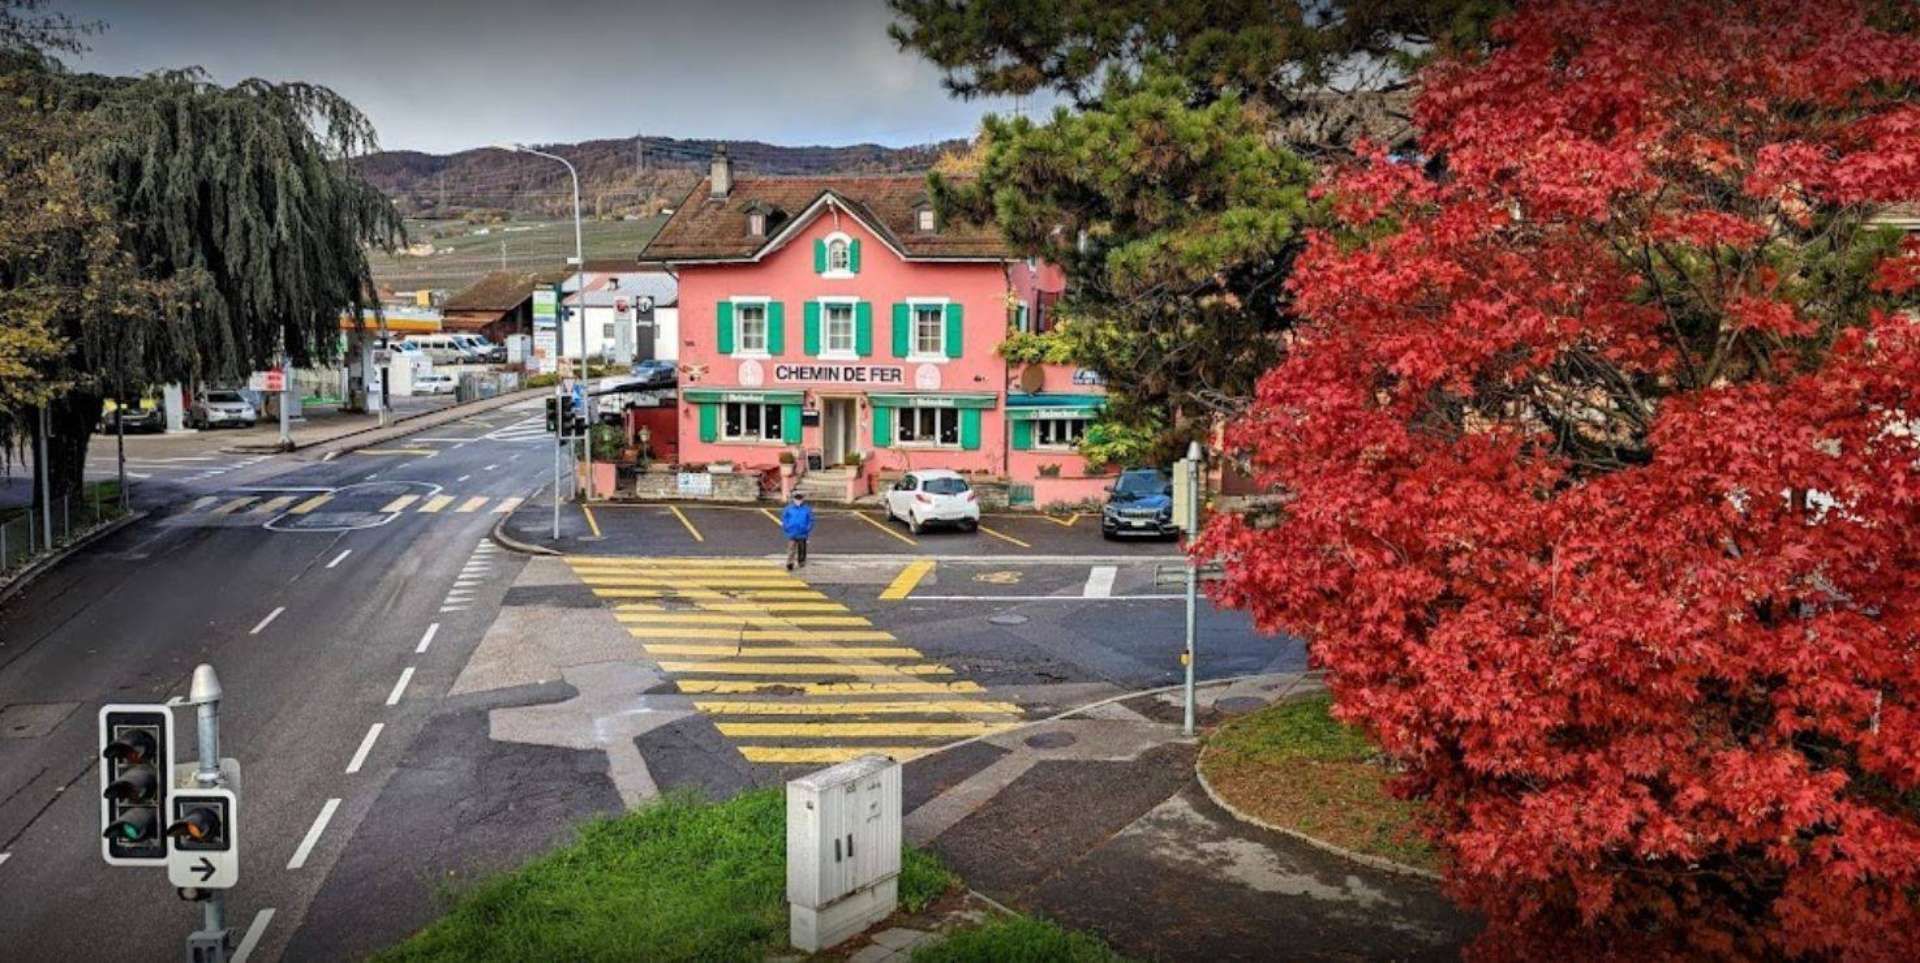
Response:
[0, 37, 403, 497]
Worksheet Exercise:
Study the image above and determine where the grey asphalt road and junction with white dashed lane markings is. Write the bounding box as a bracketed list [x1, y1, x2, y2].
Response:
[0, 403, 1304, 959]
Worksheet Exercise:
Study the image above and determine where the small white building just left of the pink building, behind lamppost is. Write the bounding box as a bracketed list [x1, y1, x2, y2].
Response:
[561, 263, 680, 363]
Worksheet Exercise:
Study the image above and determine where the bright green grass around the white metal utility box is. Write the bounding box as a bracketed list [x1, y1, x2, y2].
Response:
[376, 788, 956, 961]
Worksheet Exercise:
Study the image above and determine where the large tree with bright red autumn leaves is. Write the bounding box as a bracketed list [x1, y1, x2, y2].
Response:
[1198, 0, 1920, 959]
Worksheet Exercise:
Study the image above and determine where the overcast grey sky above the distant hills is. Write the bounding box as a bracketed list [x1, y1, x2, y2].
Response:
[56, 0, 1012, 153]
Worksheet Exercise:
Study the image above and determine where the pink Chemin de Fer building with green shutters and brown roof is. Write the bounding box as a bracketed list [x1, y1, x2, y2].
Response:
[643, 152, 1106, 505]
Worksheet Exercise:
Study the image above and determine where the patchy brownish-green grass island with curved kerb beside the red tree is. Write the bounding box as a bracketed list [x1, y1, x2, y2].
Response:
[1200, 694, 1442, 871]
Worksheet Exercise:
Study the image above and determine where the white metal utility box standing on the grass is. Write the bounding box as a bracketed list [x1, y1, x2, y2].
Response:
[787, 756, 900, 953]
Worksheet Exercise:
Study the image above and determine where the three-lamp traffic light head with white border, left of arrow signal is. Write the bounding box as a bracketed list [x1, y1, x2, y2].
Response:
[100, 706, 173, 865]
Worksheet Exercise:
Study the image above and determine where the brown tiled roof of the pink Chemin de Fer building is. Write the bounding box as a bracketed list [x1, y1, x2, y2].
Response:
[641, 175, 1012, 261]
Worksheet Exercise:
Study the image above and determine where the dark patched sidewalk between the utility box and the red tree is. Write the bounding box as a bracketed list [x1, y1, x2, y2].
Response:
[904, 675, 1475, 959]
